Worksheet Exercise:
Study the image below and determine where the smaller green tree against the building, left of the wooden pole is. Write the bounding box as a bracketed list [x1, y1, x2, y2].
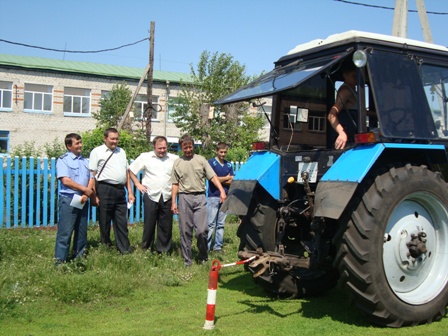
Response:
[92, 82, 132, 130]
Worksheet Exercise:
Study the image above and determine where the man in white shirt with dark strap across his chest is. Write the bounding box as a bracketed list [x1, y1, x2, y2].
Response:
[89, 128, 135, 254]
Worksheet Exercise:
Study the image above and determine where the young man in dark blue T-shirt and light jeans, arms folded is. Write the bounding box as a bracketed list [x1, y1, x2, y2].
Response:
[207, 142, 235, 252]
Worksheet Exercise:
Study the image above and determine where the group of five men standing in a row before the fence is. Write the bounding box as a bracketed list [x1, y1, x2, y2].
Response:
[55, 128, 234, 266]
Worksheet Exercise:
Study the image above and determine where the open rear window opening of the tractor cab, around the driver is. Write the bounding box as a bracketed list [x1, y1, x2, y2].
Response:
[276, 55, 378, 151]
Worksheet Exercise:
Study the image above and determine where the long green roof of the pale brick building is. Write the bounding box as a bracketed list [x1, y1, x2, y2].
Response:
[0, 54, 191, 83]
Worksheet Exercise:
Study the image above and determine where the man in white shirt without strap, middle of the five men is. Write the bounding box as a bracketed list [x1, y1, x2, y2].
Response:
[129, 136, 178, 253]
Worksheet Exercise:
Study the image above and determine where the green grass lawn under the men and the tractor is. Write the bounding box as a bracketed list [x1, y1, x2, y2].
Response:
[0, 223, 448, 336]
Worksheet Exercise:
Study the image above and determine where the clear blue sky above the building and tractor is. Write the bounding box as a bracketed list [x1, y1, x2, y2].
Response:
[0, 0, 448, 75]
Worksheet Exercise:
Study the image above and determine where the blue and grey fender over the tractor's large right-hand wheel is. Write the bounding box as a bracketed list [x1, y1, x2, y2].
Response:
[314, 143, 447, 219]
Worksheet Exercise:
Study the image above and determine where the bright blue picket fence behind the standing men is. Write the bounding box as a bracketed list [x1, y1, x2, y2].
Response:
[0, 157, 243, 229]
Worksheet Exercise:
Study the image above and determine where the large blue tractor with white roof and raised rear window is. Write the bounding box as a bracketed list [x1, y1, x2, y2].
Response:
[216, 31, 448, 327]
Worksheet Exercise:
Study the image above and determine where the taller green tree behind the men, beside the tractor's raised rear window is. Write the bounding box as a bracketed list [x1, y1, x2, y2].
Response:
[173, 51, 263, 153]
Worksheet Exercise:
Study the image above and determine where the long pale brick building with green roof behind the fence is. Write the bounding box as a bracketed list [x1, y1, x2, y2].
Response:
[0, 54, 190, 152]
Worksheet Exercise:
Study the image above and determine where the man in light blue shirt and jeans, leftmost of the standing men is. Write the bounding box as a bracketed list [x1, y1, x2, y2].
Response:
[54, 133, 94, 265]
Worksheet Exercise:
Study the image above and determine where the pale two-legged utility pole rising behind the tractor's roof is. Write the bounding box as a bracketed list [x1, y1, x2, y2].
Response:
[392, 0, 433, 43]
